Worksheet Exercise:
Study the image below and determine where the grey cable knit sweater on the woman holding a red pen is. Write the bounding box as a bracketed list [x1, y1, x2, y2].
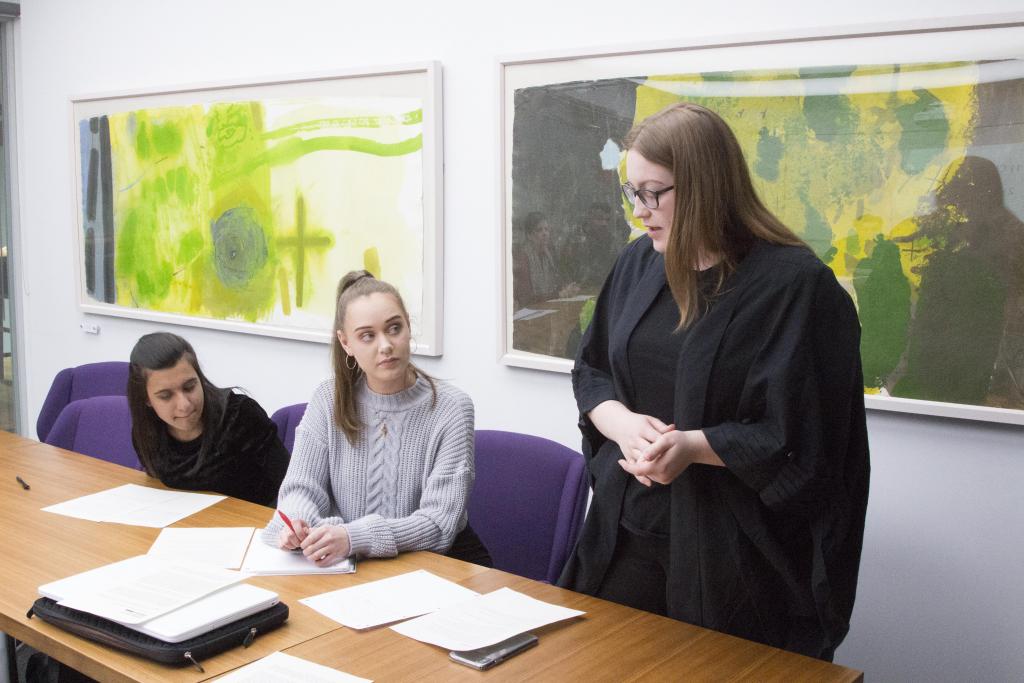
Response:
[262, 377, 474, 557]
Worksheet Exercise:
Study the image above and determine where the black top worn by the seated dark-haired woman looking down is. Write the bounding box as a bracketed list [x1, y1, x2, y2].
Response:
[136, 392, 290, 507]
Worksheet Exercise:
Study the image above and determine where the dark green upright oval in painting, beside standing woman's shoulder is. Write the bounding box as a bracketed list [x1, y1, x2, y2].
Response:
[853, 234, 910, 388]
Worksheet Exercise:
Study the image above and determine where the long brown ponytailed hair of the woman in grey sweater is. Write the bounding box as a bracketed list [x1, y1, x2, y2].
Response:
[331, 270, 437, 443]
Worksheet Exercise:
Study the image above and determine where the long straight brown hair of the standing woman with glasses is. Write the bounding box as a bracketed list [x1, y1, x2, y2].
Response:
[625, 102, 810, 328]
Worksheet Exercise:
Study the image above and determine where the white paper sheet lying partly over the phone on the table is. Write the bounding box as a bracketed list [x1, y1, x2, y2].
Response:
[391, 588, 585, 650]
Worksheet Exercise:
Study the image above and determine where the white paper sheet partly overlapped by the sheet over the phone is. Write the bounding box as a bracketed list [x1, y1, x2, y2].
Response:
[299, 569, 479, 629]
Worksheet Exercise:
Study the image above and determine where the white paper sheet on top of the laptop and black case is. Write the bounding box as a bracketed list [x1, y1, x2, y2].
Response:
[39, 555, 245, 625]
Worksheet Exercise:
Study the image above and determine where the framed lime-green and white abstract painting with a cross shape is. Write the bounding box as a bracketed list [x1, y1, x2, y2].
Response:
[71, 62, 442, 355]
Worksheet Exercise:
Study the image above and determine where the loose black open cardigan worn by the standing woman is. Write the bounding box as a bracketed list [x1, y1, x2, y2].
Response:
[559, 237, 869, 659]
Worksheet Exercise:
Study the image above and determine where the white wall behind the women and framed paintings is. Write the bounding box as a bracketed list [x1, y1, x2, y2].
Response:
[17, 0, 1024, 680]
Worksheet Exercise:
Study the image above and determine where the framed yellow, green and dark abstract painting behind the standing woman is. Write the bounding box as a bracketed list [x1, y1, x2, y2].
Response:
[501, 14, 1024, 424]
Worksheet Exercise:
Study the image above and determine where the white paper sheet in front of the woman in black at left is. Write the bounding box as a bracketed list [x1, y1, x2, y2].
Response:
[43, 483, 226, 528]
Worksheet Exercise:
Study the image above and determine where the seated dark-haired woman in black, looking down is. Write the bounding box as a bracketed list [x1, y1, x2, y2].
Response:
[128, 332, 289, 506]
